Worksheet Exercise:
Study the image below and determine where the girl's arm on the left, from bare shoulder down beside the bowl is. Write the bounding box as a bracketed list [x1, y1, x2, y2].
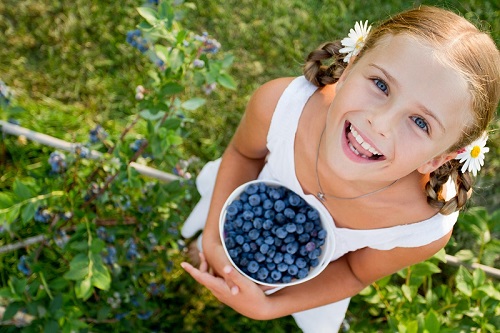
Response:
[202, 78, 293, 274]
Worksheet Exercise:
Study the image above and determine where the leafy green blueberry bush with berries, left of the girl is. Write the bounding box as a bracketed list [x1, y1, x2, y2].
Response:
[0, 1, 240, 332]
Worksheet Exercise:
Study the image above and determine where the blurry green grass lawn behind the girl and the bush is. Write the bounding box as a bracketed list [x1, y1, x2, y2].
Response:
[0, 0, 500, 332]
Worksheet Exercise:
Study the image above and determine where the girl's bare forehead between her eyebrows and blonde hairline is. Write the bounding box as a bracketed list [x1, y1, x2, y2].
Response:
[353, 35, 472, 128]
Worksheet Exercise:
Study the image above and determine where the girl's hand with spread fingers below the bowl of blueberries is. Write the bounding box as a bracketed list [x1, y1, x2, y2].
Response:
[181, 253, 269, 319]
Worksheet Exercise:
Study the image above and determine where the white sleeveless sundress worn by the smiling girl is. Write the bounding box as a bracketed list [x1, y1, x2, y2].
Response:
[181, 76, 458, 333]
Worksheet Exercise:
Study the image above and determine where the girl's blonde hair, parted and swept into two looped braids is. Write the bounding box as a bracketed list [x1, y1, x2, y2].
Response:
[304, 6, 500, 214]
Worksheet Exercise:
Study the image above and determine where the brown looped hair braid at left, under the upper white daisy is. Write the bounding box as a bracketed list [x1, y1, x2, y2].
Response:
[303, 41, 347, 87]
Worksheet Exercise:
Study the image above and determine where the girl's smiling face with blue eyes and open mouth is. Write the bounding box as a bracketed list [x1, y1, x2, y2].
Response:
[325, 35, 472, 182]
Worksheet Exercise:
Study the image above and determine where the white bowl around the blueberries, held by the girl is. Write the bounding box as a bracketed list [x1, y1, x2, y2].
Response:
[219, 180, 335, 288]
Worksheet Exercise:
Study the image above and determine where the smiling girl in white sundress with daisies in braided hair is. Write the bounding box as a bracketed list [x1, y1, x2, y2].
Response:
[182, 7, 500, 333]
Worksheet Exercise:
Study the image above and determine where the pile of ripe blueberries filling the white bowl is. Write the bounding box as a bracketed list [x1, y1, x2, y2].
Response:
[223, 182, 327, 284]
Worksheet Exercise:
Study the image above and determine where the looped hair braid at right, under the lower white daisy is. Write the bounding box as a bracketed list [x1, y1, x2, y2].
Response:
[425, 160, 472, 215]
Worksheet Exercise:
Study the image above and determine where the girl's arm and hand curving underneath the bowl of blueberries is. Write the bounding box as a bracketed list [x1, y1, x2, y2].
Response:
[183, 227, 451, 320]
